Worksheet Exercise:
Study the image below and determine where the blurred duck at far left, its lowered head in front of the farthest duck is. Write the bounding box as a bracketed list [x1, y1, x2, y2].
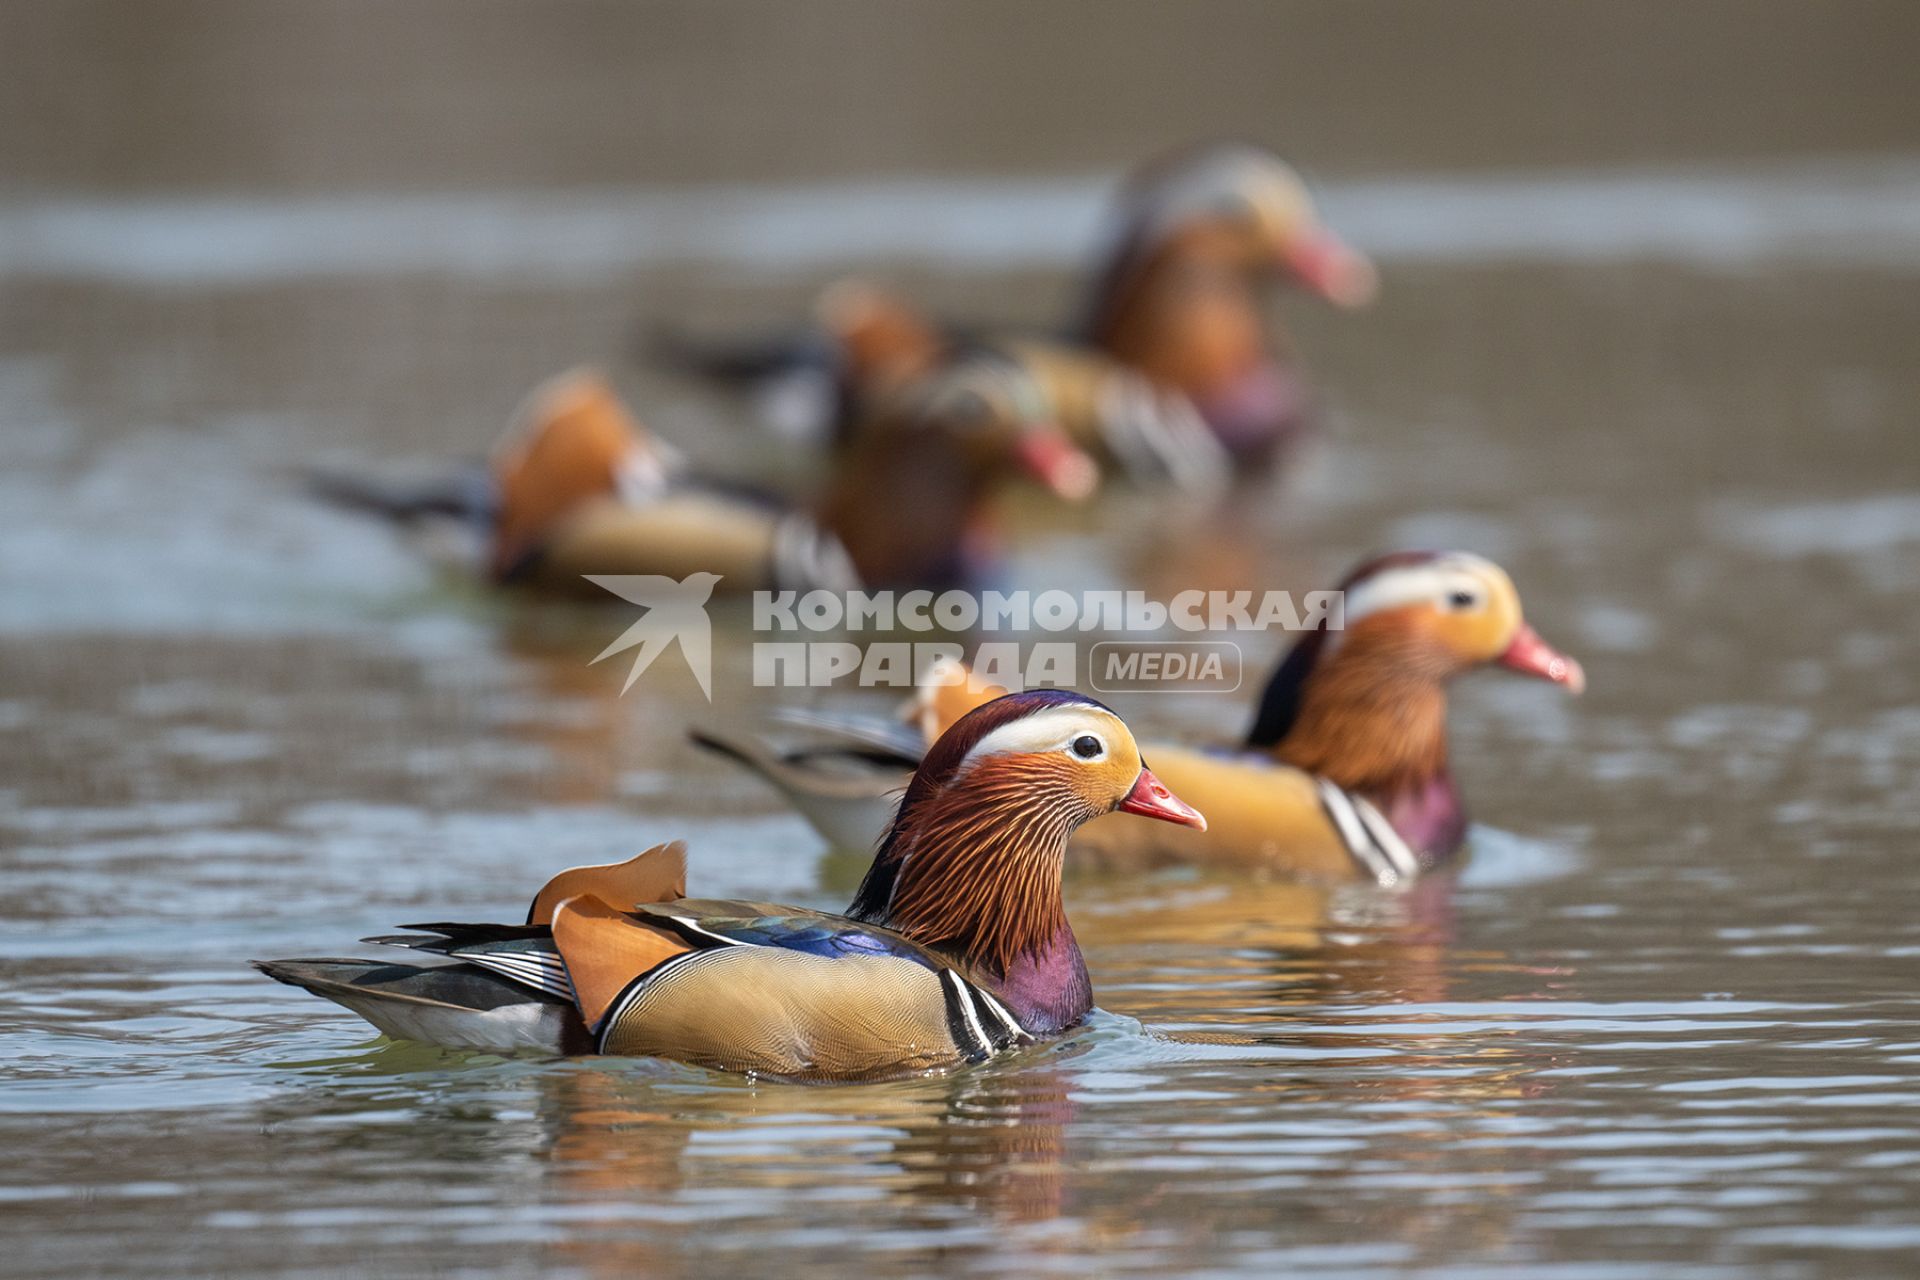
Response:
[315, 355, 1098, 593]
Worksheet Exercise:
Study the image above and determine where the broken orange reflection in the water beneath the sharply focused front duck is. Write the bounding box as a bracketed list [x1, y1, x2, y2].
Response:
[538, 1046, 1075, 1276]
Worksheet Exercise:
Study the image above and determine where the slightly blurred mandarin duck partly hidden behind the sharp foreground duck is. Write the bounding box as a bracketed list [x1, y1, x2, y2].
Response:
[693, 551, 1586, 885]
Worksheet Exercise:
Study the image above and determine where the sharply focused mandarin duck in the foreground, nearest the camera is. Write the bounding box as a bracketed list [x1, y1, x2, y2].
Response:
[257, 689, 1206, 1080]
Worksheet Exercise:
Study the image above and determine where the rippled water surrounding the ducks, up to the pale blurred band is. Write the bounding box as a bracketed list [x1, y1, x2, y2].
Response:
[0, 5, 1920, 1278]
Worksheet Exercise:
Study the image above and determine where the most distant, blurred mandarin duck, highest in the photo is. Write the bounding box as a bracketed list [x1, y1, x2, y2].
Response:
[659, 142, 1377, 484]
